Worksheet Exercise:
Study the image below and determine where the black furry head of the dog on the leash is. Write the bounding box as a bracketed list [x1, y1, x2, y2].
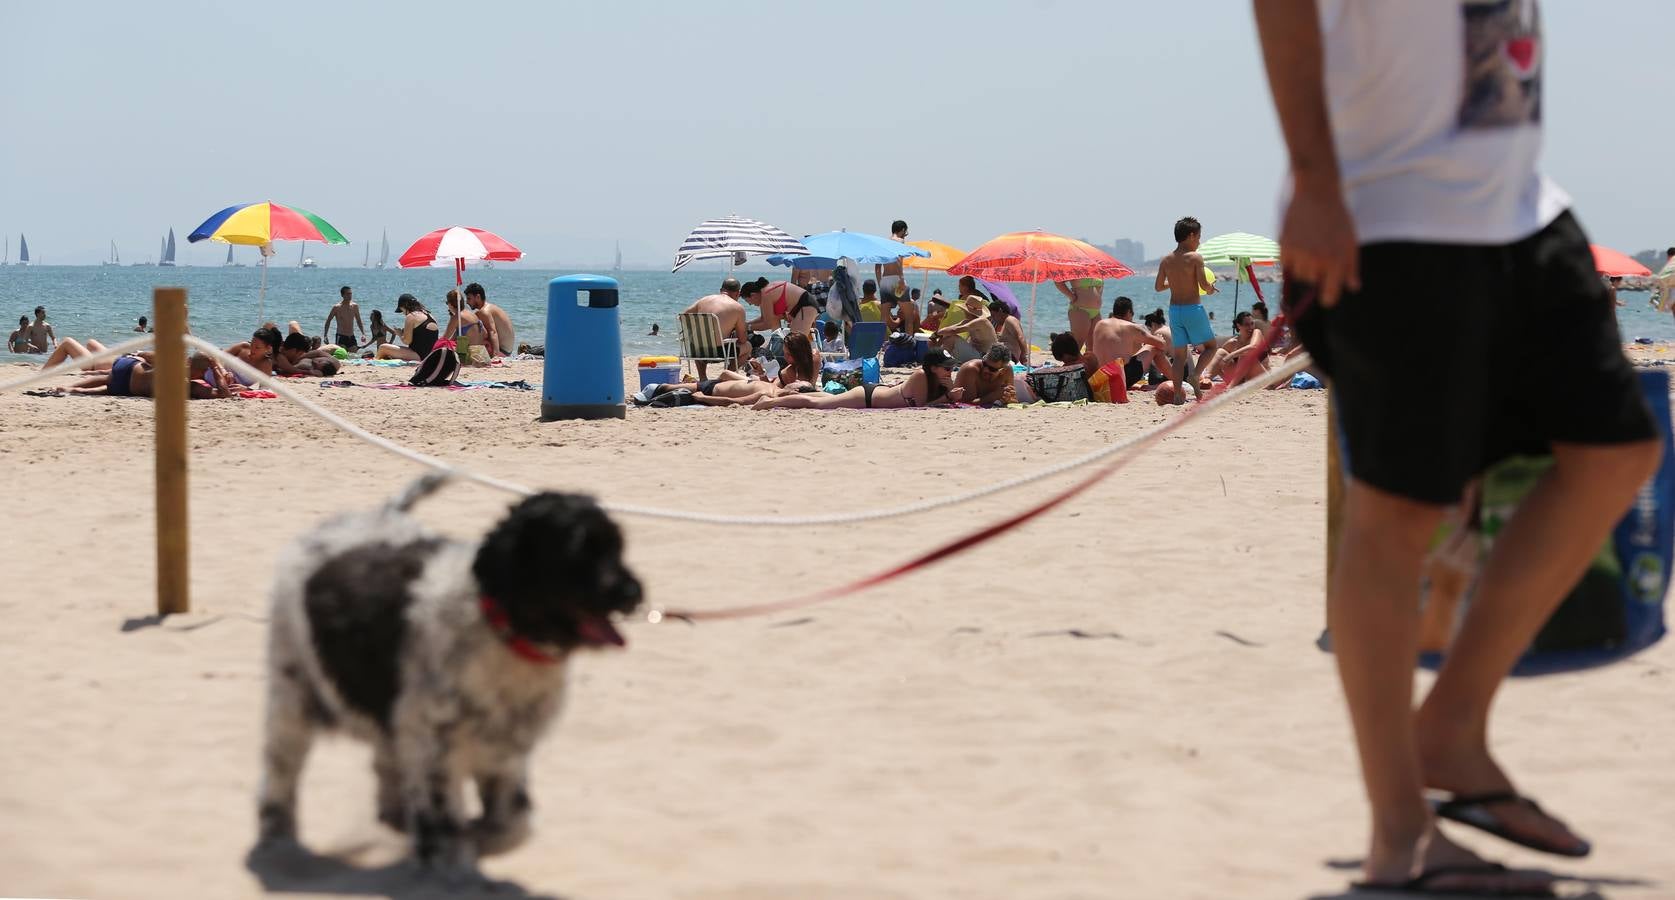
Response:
[472, 493, 640, 644]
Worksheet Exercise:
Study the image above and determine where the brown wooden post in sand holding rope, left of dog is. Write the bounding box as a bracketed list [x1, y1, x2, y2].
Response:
[151, 288, 191, 615]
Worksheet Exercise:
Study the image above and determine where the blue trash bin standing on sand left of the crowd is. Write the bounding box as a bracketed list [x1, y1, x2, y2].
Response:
[541, 275, 626, 422]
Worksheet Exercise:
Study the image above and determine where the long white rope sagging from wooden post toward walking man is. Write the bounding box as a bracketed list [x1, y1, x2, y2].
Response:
[186, 337, 1313, 526]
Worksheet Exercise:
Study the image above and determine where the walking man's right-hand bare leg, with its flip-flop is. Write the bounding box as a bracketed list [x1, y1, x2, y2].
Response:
[1415, 441, 1660, 846]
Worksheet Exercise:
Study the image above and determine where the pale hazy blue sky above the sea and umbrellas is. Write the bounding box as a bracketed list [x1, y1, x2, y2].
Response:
[0, 0, 1675, 265]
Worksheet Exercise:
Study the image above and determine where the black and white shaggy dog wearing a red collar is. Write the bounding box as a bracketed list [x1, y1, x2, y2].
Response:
[258, 478, 640, 870]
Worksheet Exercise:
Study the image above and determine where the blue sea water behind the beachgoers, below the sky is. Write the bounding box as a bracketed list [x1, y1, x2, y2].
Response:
[0, 265, 1675, 362]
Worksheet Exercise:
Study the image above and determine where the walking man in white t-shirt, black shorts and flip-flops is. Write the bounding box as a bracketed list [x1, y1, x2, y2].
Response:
[1255, 0, 1660, 895]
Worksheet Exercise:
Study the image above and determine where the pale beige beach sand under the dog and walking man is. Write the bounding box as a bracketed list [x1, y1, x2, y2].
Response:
[0, 353, 1675, 900]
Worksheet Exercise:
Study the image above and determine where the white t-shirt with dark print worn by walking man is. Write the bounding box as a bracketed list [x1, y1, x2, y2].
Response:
[1318, 0, 1569, 245]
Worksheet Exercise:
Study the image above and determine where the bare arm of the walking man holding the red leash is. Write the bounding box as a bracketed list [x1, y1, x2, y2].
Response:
[1255, 0, 1360, 307]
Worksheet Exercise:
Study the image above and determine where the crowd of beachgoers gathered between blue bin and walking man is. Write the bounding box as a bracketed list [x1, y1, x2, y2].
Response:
[635, 216, 1300, 409]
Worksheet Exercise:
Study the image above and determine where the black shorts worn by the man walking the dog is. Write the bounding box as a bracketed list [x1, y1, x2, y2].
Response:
[1285, 213, 1655, 504]
